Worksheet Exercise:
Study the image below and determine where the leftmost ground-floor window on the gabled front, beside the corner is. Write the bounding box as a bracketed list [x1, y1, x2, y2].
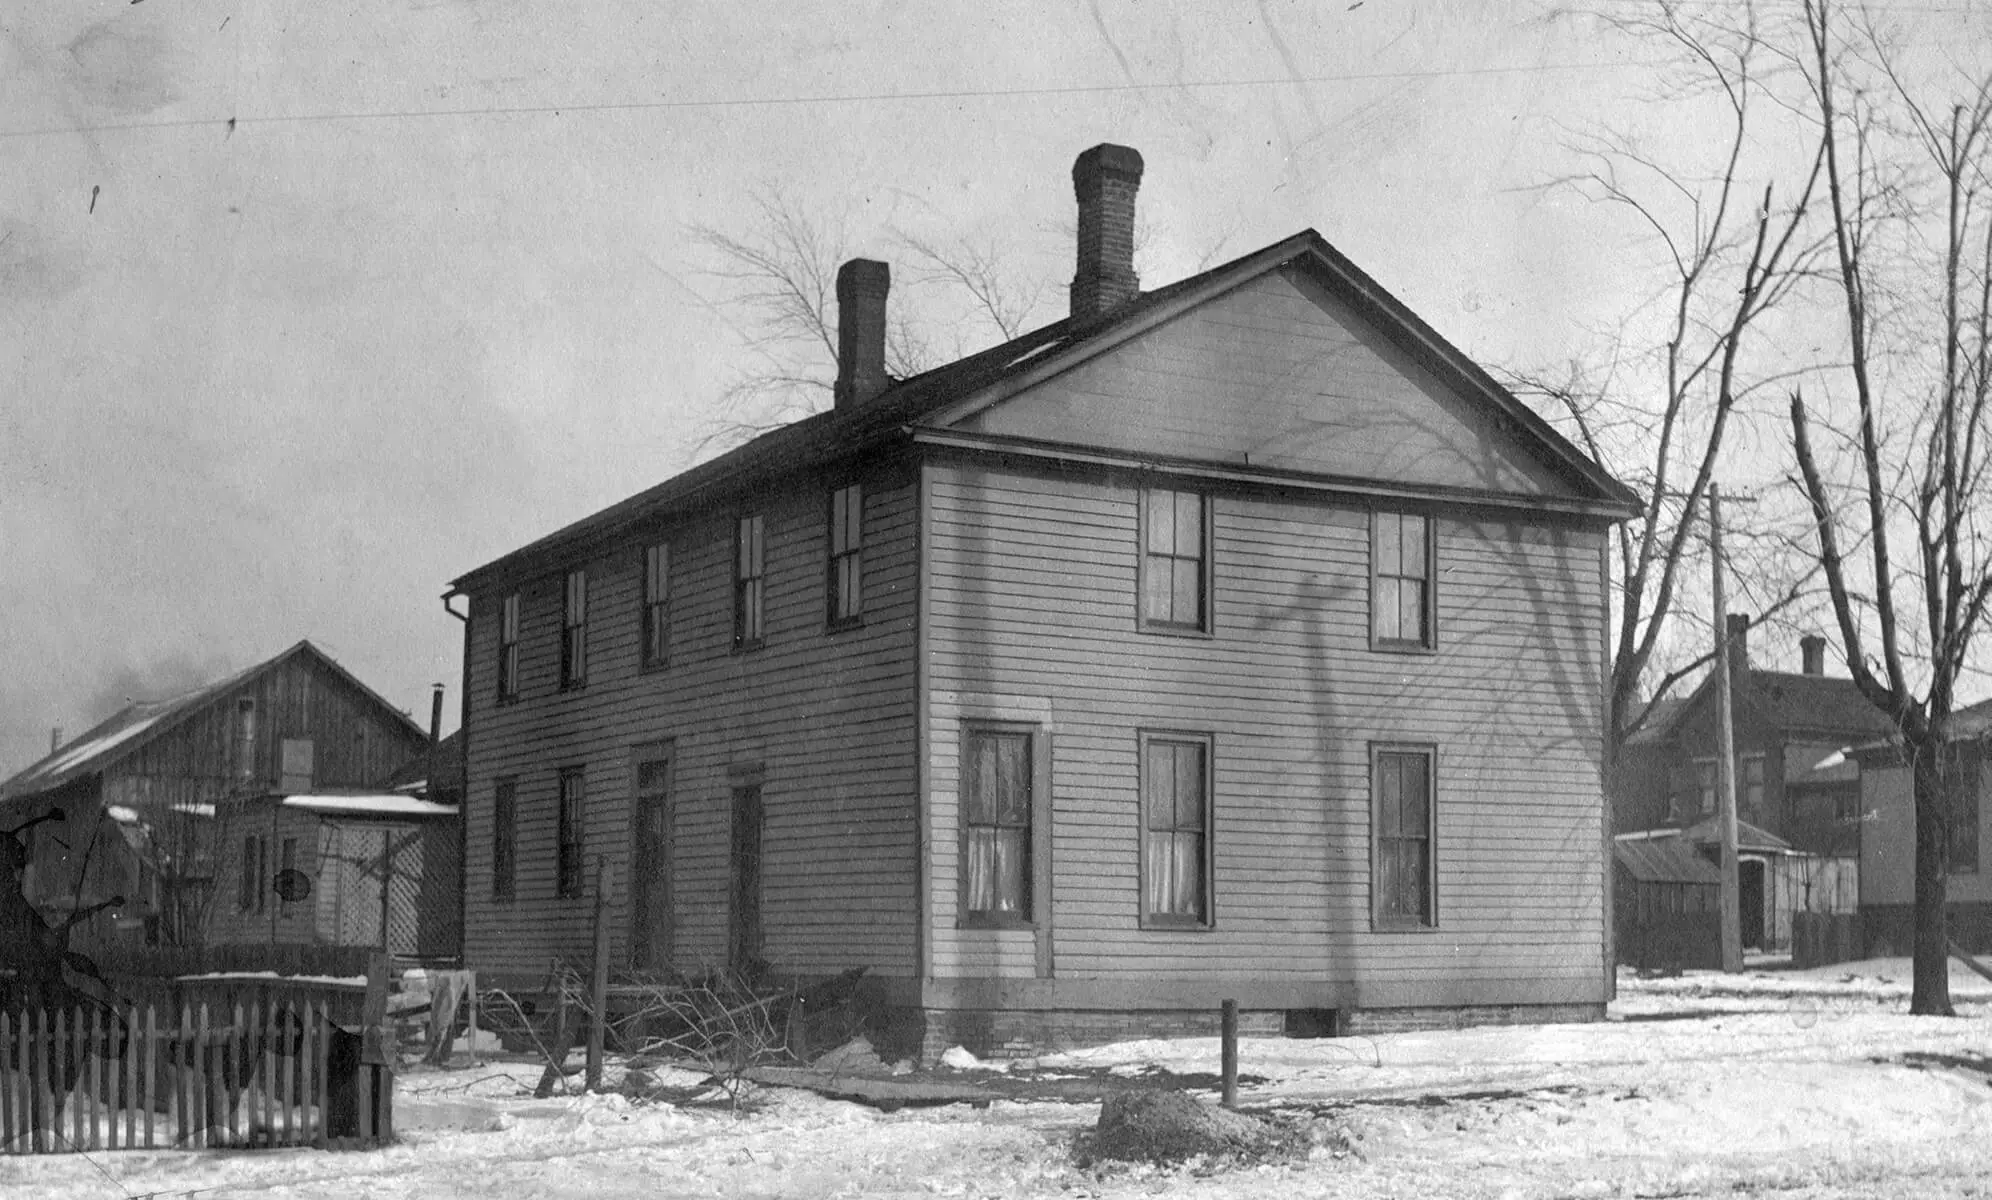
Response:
[962, 730, 1032, 925]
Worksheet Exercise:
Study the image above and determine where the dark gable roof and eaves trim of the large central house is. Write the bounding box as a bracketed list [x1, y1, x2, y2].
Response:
[448, 229, 1637, 594]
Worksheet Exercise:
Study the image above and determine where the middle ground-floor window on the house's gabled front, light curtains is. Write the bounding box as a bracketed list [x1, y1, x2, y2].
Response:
[1141, 734, 1211, 927]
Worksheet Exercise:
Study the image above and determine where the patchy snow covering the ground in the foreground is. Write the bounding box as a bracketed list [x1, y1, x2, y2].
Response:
[11, 959, 1992, 1200]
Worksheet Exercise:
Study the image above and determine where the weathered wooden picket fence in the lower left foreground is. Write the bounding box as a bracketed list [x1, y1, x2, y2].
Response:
[0, 995, 394, 1154]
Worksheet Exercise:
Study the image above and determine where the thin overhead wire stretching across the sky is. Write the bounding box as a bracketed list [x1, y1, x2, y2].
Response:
[0, 58, 1669, 138]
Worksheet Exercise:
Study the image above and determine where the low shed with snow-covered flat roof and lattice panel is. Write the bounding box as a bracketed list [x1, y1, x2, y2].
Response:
[207, 789, 462, 959]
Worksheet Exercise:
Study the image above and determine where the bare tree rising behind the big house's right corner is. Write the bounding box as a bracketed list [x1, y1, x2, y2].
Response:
[1508, 0, 1821, 765]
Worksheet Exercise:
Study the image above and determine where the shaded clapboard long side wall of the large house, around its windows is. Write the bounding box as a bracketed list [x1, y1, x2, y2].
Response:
[464, 466, 916, 981]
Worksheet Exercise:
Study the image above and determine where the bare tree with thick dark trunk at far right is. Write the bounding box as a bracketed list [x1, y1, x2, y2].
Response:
[1791, 0, 1992, 1015]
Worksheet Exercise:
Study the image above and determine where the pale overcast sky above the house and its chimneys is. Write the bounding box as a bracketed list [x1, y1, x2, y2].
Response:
[0, 0, 1988, 775]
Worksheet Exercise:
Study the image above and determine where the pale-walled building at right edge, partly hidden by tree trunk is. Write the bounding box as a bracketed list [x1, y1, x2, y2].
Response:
[1853, 700, 1992, 955]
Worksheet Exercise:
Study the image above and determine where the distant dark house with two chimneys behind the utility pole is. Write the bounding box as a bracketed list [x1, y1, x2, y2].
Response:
[1612, 614, 1888, 949]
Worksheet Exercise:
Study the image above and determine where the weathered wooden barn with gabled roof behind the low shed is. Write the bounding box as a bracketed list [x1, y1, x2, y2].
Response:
[0, 642, 428, 943]
